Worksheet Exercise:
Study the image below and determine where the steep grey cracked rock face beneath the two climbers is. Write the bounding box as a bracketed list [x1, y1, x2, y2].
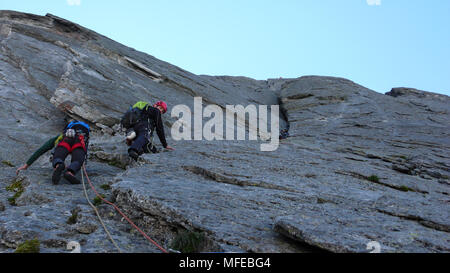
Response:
[0, 11, 450, 252]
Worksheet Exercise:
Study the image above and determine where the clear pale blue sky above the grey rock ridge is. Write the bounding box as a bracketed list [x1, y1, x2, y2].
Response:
[0, 0, 450, 95]
